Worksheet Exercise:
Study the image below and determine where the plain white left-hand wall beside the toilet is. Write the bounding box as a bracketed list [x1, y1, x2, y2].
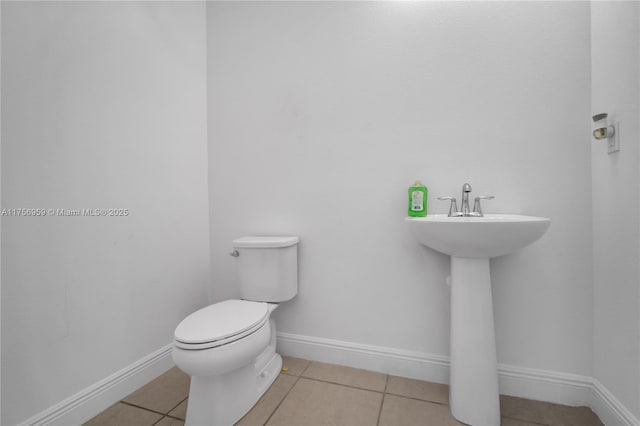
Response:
[1, 2, 209, 425]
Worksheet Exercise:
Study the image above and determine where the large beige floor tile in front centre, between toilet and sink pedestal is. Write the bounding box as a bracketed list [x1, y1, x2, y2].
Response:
[267, 378, 382, 426]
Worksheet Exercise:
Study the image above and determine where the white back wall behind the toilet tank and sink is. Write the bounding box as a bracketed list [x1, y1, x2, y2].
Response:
[207, 2, 593, 376]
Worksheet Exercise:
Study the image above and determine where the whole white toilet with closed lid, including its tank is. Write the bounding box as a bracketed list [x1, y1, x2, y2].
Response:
[172, 236, 299, 425]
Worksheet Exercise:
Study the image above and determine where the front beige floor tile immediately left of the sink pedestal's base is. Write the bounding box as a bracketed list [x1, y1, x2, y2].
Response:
[379, 395, 462, 426]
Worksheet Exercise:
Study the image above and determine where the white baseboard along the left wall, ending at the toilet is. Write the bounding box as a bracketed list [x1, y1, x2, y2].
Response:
[20, 344, 173, 426]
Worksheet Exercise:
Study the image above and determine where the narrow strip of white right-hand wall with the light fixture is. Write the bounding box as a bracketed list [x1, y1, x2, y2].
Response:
[591, 2, 640, 418]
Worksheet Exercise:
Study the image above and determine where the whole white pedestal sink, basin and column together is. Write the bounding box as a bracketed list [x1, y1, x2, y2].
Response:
[405, 214, 551, 426]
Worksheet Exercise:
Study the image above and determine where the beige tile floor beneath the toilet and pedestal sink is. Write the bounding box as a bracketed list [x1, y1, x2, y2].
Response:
[85, 357, 602, 426]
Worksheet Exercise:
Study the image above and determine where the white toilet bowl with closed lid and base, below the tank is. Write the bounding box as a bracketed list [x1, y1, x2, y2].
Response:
[173, 300, 282, 425]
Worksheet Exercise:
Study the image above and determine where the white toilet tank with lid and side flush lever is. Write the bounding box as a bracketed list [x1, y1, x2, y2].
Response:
[233, 236, 300, 302]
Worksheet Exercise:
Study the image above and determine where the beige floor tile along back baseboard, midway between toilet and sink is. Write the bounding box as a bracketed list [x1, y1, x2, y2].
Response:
[302, 362, 387, 392]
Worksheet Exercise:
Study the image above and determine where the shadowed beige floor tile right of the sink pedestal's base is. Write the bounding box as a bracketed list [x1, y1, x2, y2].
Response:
[500, 395, 602, 426]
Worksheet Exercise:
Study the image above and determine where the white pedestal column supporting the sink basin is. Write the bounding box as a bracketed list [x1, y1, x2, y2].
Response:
[449, 256, 500, 426]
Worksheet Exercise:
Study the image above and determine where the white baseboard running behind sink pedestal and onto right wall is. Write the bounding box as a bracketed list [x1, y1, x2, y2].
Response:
[277, 332, 640, 426]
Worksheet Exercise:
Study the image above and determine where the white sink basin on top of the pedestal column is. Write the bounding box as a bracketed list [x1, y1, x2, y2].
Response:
[405, 214, 551, 258]
